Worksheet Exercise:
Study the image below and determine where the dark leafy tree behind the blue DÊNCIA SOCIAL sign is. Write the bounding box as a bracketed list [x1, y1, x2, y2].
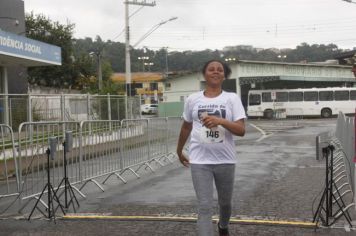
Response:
[25, 12, 91, 88]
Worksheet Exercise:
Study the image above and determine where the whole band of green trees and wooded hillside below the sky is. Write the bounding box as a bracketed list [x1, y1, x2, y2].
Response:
[26, 12, 350, 90]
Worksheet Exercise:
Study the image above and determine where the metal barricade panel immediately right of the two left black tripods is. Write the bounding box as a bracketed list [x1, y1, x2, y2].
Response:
[80, 120, 122, 191]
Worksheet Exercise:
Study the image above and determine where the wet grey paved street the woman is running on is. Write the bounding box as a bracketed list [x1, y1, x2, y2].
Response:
[0, 119, 356, 235]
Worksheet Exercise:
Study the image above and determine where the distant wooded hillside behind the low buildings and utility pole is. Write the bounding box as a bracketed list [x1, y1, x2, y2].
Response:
[76, 38, 342, 73]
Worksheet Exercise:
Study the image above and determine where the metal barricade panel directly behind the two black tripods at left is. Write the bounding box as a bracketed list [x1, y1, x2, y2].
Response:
[18, 121, 81, 200]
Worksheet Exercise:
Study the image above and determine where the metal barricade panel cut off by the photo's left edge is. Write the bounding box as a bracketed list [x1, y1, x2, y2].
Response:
[0, 124, 19, 200]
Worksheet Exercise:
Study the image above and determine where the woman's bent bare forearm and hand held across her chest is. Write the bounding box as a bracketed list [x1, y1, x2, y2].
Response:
[202, 116, 245, 137]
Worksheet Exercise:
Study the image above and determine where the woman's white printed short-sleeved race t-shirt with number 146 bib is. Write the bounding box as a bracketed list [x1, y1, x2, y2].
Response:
[183, 91, 246, 164]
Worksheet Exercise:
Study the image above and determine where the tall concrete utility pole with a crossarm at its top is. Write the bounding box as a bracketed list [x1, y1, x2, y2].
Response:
[124, 0, 156, 96]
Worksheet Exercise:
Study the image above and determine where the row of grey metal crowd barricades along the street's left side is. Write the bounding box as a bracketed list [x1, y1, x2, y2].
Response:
[0, 117, 181, 214]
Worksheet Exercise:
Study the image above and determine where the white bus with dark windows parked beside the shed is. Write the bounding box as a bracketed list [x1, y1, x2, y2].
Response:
[247, 87, 356, 119]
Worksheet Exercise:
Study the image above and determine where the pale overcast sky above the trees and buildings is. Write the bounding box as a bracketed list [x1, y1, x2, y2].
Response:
[24, 0, 356, 51]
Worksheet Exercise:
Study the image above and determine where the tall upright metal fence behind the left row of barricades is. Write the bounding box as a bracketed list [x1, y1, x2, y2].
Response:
[0, 94, 141, 129]
